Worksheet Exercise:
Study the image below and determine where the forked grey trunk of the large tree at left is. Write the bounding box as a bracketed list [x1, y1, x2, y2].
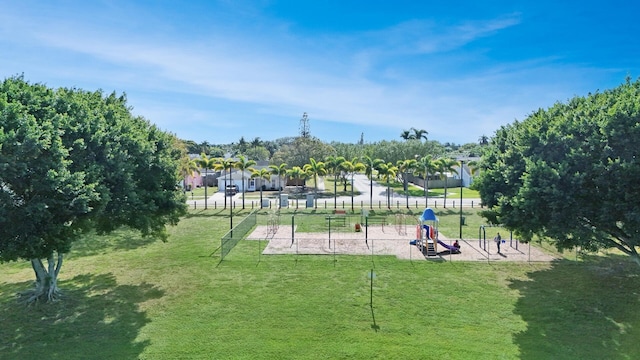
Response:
[20, 253, 63, 304]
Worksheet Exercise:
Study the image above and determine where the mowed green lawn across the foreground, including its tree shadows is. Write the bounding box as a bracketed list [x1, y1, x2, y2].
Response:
[0, 210, 640, 359]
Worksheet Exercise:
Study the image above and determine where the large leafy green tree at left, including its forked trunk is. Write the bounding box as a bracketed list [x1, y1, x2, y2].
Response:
[0, 77, 186, 302]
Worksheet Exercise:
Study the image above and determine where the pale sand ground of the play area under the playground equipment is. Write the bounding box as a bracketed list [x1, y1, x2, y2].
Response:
[247, 225, 554, 262]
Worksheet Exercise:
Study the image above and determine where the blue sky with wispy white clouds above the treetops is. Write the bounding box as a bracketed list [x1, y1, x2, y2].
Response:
[0, 0, 640, 144]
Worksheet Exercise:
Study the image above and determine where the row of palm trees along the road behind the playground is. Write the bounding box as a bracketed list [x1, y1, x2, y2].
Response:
[181, 154, 470, 210]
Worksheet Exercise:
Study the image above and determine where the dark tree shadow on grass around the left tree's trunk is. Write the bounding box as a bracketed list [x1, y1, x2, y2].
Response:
[0, 274, 164, 359]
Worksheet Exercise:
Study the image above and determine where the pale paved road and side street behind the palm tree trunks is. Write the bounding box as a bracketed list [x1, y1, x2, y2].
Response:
[187, 174, 480, 208]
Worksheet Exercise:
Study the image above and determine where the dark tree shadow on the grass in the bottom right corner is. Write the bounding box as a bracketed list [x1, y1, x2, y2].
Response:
[510, 256, 640, 360]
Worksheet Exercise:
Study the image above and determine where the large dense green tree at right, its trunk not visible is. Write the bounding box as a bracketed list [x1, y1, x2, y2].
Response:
[474, 80, 640, 265]
